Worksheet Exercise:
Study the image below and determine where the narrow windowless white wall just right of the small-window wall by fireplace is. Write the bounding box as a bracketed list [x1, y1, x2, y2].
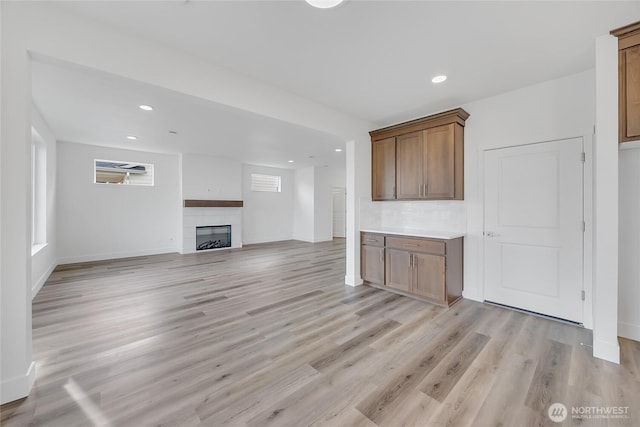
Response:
[293, 166, 315, 242]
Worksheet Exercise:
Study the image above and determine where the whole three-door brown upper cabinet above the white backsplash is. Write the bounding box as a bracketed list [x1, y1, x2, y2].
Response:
[370, 108, 469, 201]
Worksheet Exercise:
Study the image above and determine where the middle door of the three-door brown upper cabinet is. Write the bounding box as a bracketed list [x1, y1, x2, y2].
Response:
[396, 132, 424, 199]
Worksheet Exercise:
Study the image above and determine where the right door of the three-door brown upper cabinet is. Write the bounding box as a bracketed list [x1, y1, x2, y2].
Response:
[423, 124, 455, 199]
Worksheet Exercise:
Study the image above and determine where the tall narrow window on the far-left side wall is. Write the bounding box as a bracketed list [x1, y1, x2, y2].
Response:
[31, 128, 47, 250]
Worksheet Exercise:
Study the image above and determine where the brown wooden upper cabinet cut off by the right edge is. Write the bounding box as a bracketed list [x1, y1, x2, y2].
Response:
[611, 22, 640, 142]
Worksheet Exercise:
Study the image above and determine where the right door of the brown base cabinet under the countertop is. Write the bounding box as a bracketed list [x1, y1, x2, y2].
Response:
[411, 254, 445, 302]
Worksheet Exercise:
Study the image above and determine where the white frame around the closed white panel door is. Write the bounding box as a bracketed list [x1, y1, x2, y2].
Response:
[478, 135, 593, 329]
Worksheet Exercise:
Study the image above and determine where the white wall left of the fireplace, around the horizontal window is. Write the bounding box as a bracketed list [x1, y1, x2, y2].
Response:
[58, 142, 182, 264]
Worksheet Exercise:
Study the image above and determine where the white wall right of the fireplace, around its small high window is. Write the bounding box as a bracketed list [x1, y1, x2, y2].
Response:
[242, 164, 295, 244]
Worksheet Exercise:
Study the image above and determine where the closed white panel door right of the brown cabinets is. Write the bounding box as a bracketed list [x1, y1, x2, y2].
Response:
[484, 138, 584, 323]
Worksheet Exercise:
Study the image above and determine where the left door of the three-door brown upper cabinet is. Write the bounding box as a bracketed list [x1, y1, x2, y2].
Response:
[371, 138, 396, 200]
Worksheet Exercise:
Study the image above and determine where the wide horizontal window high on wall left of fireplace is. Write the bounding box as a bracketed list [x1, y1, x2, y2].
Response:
[93, 160, 154, 187]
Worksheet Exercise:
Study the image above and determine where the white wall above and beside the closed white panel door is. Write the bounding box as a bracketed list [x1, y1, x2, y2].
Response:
[463, 70, 595, 314]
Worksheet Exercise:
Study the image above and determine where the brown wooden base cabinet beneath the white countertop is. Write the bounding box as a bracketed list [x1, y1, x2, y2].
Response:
[362, 233, 463, 306]
